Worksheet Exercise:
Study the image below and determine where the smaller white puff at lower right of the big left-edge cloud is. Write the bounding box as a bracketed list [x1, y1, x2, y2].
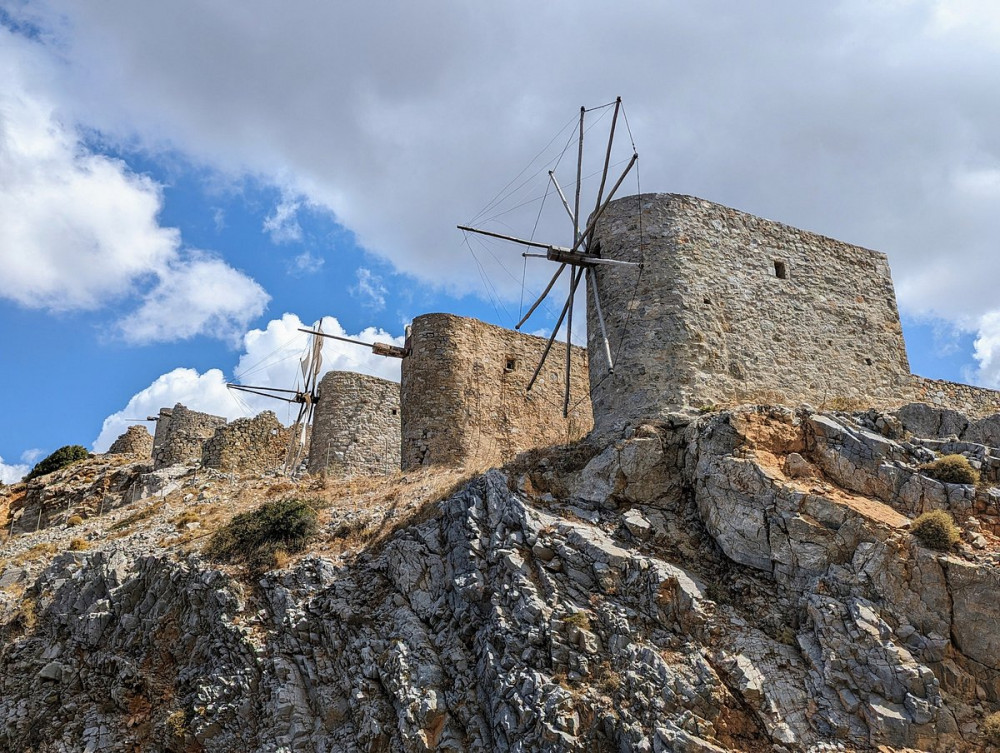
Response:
[119, 253, 269, 343]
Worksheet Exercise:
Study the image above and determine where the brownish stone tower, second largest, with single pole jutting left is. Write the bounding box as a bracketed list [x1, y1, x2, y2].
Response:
[400, 314, 593, 470]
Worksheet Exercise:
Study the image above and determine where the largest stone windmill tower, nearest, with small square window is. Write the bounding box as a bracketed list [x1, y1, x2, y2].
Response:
[587, 194, 912, 429]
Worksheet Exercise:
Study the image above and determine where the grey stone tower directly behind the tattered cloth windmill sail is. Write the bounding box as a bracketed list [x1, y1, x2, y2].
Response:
[307, 371, 400, 476]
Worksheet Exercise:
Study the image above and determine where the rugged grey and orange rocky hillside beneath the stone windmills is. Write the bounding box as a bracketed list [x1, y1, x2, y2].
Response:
[0, 406, 1000, 753]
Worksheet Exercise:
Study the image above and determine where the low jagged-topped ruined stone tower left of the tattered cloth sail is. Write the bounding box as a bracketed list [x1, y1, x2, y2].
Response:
[201, 410, 290, 473]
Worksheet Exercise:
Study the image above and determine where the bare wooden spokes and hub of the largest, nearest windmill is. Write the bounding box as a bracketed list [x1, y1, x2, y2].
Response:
[458, 97, 639, 417]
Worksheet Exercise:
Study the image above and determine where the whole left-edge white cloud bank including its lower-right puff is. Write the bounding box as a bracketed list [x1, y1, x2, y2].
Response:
[0, 26, 268, 343]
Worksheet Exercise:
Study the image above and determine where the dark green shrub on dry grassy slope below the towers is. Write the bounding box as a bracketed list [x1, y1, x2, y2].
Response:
[205, 499, 316, 569]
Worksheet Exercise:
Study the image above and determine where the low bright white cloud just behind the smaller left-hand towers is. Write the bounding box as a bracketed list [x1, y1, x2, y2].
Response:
[93, 313, 403, 452]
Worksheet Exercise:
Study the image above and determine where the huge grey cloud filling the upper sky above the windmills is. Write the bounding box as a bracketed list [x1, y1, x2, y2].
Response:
[11, 0, 1000, 382]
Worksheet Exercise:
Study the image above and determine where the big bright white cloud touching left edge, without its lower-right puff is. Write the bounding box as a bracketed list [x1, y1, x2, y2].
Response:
[0, 27, 179, 310]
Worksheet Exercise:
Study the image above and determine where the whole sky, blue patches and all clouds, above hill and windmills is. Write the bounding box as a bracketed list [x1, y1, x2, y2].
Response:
[0, 0, 1000, 481]
